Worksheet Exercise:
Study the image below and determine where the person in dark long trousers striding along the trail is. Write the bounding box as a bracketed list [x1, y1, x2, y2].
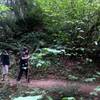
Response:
[17, 47, 29, 81]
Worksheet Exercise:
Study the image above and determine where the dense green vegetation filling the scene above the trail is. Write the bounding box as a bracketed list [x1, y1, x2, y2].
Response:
[0, 0, 100, 100]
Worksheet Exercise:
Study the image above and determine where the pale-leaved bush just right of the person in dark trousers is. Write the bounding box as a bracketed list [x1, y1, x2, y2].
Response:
[30, 48, 64, 68]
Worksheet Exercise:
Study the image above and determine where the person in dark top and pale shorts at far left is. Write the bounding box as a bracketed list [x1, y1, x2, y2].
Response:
[1, 50, 10, 81]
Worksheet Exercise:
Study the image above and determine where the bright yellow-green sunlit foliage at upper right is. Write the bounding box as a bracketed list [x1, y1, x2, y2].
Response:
[36, 0, 100, 32]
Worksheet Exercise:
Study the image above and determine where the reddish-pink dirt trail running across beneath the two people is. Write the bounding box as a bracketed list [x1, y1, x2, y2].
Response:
[0, 79, 100, 95]
